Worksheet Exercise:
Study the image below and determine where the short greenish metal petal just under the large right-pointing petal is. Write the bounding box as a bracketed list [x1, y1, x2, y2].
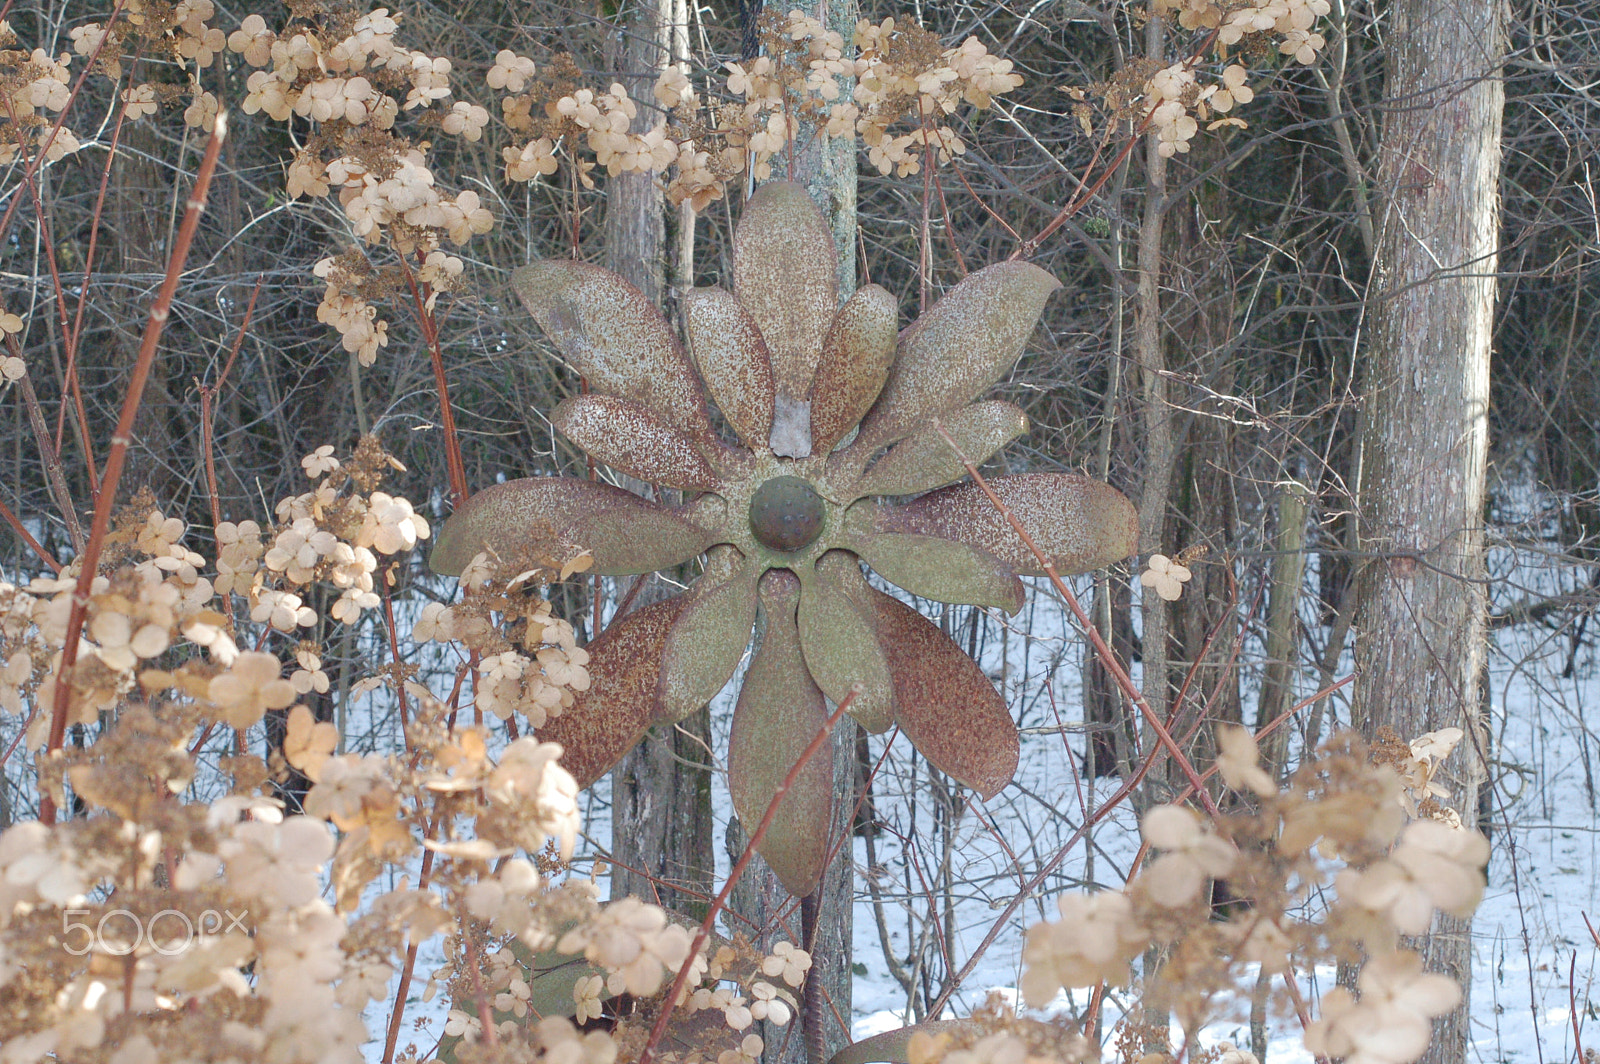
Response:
[846, 531, 1022, 613]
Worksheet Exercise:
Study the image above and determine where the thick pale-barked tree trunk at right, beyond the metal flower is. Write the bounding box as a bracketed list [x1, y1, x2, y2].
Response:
[1355, 0, 1504, 1062]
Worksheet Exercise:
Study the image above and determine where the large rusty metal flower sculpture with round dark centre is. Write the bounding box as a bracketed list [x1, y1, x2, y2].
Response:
[430, 182, 1138, 894]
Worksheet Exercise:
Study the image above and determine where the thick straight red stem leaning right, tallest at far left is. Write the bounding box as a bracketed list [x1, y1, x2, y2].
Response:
[38, 112, 227, 824]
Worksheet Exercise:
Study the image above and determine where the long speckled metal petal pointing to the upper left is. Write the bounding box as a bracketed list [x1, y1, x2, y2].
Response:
[510, 259, 715, 442]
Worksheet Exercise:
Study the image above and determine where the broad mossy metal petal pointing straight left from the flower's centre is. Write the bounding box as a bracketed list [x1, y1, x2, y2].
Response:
[427, 477, 715, 576]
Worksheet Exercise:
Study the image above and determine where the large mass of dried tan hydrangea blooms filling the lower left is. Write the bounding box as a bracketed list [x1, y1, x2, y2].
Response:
[0, 502, 810, 1064]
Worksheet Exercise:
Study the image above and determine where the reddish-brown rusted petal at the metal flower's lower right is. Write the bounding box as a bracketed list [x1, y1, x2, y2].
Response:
[872, 590, 1019, 798]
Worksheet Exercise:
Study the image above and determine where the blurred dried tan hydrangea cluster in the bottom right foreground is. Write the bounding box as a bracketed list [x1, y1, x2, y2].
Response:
[1021, 726, 1488, 1064]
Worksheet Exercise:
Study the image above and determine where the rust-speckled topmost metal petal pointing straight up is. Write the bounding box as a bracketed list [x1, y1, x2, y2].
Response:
[733, 181, 838, 400]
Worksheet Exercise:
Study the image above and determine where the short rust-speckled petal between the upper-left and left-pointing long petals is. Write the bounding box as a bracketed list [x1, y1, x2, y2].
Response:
[550, 395, 722, 491]
